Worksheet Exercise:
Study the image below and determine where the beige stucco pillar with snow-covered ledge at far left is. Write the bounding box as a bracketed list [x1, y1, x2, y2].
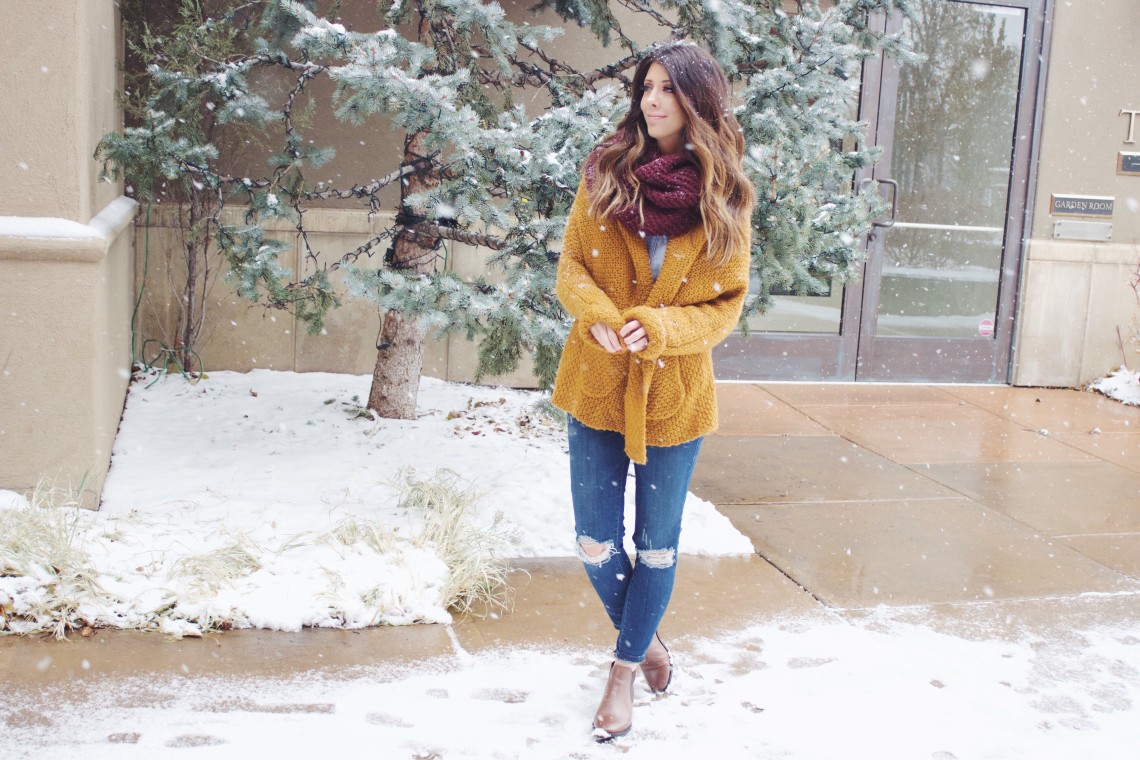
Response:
[0, 0, 136, 505]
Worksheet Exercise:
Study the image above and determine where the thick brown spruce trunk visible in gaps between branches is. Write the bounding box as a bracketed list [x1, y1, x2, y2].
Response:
[368, 132, 439, 419]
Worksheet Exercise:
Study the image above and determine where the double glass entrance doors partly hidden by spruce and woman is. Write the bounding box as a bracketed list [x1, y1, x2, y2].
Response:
[717, 0, 1045, 383]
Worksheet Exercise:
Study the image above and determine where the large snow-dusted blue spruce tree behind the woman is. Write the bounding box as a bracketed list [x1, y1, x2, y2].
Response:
[97, 0, 905, 417]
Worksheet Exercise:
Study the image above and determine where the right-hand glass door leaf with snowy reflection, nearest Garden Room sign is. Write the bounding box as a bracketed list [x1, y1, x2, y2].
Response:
[856, 0, 1028, 382]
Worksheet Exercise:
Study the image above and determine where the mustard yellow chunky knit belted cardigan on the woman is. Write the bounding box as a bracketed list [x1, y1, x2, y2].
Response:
[552, 181, 749, 464]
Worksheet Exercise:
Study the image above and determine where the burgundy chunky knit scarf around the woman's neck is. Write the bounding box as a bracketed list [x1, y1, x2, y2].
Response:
[586, 148, 701, 237]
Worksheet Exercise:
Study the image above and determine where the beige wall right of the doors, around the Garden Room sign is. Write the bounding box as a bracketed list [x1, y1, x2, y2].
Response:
[1012, 0, 1140, 386]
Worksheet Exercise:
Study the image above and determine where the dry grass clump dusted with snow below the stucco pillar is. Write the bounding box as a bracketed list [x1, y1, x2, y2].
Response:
[0, 480, 105, 638]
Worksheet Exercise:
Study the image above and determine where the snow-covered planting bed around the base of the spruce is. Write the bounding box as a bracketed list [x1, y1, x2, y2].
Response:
[0, 370, 752, 635]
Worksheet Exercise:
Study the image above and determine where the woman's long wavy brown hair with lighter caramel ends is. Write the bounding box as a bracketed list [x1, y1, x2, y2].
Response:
[589, 42, 756, 263]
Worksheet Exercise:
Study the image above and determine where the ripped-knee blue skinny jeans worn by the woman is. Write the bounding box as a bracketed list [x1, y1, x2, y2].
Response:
[569, 417, 701, 663]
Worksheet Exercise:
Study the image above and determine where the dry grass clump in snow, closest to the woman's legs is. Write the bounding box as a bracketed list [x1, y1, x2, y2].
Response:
[392, 468, 513, 616]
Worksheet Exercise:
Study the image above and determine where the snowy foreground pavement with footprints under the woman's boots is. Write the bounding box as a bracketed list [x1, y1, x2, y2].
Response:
[0, 611, 1140, 760]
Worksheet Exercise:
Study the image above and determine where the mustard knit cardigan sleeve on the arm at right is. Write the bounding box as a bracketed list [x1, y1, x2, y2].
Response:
[621, 243, 749, 361]
